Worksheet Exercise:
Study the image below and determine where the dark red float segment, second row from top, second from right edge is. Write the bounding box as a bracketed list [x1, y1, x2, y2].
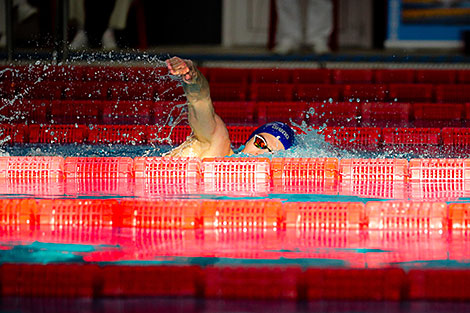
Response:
[389, 84, 433, 102]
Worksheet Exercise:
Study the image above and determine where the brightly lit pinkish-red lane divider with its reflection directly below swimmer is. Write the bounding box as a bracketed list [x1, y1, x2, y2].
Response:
[0, 157, 470, 197]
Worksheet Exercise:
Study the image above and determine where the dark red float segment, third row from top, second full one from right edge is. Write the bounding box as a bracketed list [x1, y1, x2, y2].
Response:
[361, 102, 411, 127]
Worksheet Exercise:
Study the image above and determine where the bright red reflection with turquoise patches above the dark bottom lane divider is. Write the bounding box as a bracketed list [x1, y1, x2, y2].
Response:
[0, 225, 464, 268]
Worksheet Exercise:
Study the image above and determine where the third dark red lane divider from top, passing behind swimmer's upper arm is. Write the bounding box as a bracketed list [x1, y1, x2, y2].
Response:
[0, 99, 470, 127]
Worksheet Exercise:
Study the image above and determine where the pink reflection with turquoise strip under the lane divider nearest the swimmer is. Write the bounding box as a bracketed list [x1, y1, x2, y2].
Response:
[0, 178, 470, 202]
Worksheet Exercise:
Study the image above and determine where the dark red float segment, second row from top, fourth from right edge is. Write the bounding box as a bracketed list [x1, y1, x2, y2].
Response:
[294, 84, 343, 101]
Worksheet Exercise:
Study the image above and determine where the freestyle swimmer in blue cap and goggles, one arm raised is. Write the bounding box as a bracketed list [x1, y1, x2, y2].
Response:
[164, 57, 295, 158]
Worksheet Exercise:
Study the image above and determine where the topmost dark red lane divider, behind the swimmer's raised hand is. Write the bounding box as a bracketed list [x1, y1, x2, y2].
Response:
[0, 65, 470, 84]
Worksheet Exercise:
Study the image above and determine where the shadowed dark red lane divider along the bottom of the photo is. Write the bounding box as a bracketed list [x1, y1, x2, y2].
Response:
[5, 262, 470, 298]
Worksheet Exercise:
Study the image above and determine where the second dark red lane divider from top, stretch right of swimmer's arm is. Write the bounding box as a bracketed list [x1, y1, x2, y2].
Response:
[211, 83, 470, 103]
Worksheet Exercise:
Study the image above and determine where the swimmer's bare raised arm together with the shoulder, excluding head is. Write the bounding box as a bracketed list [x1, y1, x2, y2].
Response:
[164, 57, 233, 158]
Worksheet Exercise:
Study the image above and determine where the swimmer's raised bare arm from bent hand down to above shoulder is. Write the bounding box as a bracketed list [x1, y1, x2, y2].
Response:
[166, 57, 216, 143]
